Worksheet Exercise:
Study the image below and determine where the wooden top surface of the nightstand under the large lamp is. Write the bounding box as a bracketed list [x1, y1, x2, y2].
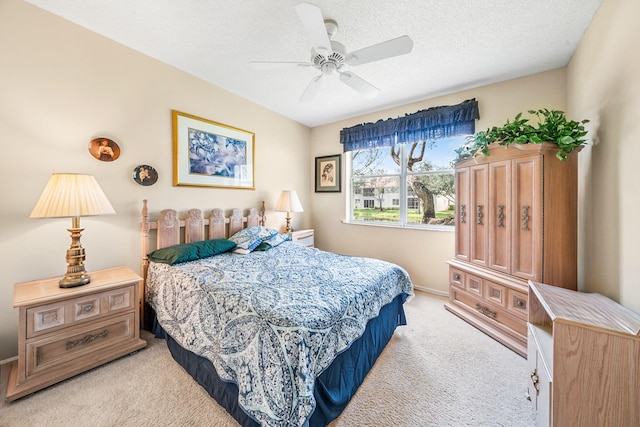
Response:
[13, 266, 142, 308]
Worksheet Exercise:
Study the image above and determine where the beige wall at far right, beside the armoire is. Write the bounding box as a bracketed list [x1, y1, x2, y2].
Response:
[567, 0, 640, 312]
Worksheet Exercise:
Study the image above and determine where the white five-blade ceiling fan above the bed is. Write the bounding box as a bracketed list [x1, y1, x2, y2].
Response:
[251, 3, 413, 101]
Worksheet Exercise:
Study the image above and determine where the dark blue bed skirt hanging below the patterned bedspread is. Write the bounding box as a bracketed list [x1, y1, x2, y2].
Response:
[145, 294, 407, 427]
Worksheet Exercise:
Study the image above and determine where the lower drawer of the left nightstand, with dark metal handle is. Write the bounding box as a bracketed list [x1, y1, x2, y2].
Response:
[26, 312, 137, 377]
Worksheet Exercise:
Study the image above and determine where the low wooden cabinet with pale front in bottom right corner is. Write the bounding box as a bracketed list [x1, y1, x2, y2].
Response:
[527, 282, 640, 427]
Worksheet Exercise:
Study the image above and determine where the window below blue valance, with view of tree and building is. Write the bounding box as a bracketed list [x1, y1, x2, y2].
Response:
[347, 136, 465, 227]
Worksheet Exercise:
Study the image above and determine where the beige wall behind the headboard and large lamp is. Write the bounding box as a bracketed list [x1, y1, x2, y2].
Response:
[0, 0, 311, 360]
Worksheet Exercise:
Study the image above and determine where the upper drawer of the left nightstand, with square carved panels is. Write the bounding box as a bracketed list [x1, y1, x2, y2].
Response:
[27, 284, 135, 339]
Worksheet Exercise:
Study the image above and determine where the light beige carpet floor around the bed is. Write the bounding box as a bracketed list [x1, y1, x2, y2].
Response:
[0, 291, 535, 427]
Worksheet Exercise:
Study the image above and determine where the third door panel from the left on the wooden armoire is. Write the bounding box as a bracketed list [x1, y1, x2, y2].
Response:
[488, 160, 512, 274]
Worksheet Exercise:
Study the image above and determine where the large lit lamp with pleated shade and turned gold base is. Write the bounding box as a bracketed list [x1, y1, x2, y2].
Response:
[29, 173, 116, 288]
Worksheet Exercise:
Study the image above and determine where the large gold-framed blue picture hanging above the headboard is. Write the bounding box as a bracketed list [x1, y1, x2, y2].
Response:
[172, 110, 255, 190]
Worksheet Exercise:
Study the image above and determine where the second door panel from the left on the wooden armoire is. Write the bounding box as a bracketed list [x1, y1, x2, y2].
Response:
[468, 165, 489, 266]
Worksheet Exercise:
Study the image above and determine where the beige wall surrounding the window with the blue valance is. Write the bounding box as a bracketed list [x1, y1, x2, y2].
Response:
[309, 69, 566, 295]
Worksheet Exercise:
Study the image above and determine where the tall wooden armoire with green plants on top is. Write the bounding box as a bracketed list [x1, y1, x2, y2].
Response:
[445, 143, 578, 357]
